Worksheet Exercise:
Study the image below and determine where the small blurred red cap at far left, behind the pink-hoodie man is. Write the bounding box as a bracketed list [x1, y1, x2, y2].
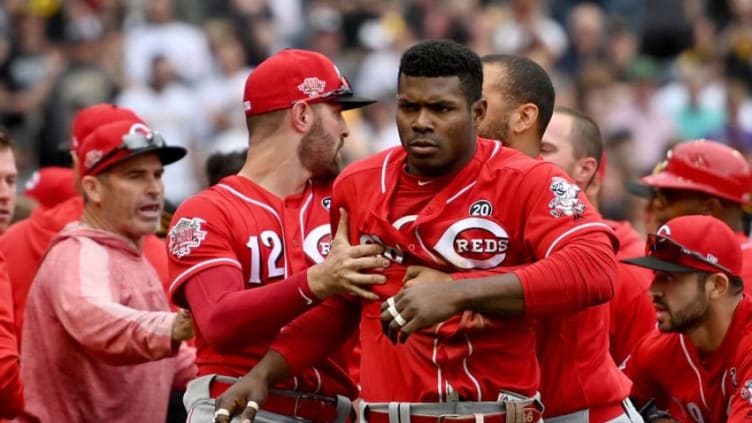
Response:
[23, 166, 78, 208]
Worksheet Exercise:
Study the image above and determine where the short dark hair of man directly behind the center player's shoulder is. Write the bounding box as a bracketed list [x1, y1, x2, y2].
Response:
[481, 54, 556, 137]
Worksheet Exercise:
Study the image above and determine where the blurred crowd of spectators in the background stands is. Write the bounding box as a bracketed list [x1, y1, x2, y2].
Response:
[0, 0, 752, 234]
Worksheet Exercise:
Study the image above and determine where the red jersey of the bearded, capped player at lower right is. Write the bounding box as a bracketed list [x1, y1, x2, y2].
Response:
[624, 294, 752, 423]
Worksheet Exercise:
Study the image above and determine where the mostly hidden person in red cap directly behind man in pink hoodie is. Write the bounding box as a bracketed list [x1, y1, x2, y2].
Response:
[0, 103, 176, 345]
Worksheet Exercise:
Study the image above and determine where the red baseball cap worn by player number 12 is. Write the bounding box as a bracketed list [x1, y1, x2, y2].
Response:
[243, 49, 375, 116]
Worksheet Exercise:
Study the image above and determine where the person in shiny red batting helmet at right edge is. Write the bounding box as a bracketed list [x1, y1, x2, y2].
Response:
[628, 140, 752, 294]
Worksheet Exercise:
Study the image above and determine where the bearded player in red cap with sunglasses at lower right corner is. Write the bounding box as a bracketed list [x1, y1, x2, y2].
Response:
[624, 215, 752, 423]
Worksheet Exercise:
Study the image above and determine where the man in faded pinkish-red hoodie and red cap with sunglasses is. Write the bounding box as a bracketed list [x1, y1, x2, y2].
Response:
[19, 119, 193, 422]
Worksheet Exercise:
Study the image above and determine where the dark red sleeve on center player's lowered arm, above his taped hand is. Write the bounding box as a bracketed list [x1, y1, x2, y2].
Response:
[270, 295, 360, 374]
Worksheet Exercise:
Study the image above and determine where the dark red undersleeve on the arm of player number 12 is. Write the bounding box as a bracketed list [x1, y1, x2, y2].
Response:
[185, 266, 318, 352]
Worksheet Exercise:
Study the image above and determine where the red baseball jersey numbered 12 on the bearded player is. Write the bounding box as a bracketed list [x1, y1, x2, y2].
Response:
[168, 176, 349, 392]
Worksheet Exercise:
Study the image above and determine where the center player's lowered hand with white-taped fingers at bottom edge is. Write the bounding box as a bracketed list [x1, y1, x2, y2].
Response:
[214, 373, 269, 423]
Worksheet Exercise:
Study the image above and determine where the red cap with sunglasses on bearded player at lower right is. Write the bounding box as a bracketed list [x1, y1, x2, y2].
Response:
[622, 215, 742, 280]
